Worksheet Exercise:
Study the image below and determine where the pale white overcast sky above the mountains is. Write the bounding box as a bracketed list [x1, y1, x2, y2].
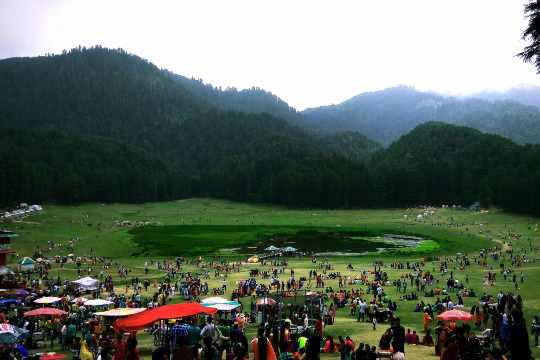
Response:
[0, 0, 540, 110]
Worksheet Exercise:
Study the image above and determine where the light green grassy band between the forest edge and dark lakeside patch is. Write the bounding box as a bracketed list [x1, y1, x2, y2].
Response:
[4, 199, 506, 258]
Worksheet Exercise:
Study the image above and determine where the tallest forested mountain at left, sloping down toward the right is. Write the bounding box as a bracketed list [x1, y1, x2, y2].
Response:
[0, 47, 373, 206]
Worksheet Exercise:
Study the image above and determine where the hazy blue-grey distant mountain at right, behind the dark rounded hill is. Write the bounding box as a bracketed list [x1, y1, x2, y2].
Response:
[303, 86, 540, 144]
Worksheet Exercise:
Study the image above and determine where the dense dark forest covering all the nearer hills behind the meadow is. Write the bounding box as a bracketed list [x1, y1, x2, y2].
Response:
[0, 47, 540, 214]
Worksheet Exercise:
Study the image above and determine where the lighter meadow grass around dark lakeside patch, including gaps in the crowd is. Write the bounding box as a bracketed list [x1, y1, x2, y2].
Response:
[4, 199, 540, 359]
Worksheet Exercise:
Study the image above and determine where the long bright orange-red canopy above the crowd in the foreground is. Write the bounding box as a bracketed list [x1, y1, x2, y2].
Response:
[114, 303, 217, 331]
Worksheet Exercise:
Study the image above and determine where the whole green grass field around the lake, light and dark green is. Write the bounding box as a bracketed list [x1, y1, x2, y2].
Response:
[1, 199, 540, 359]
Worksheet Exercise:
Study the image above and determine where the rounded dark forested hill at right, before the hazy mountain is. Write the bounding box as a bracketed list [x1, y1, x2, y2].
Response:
[371, 122, 540, 212]
